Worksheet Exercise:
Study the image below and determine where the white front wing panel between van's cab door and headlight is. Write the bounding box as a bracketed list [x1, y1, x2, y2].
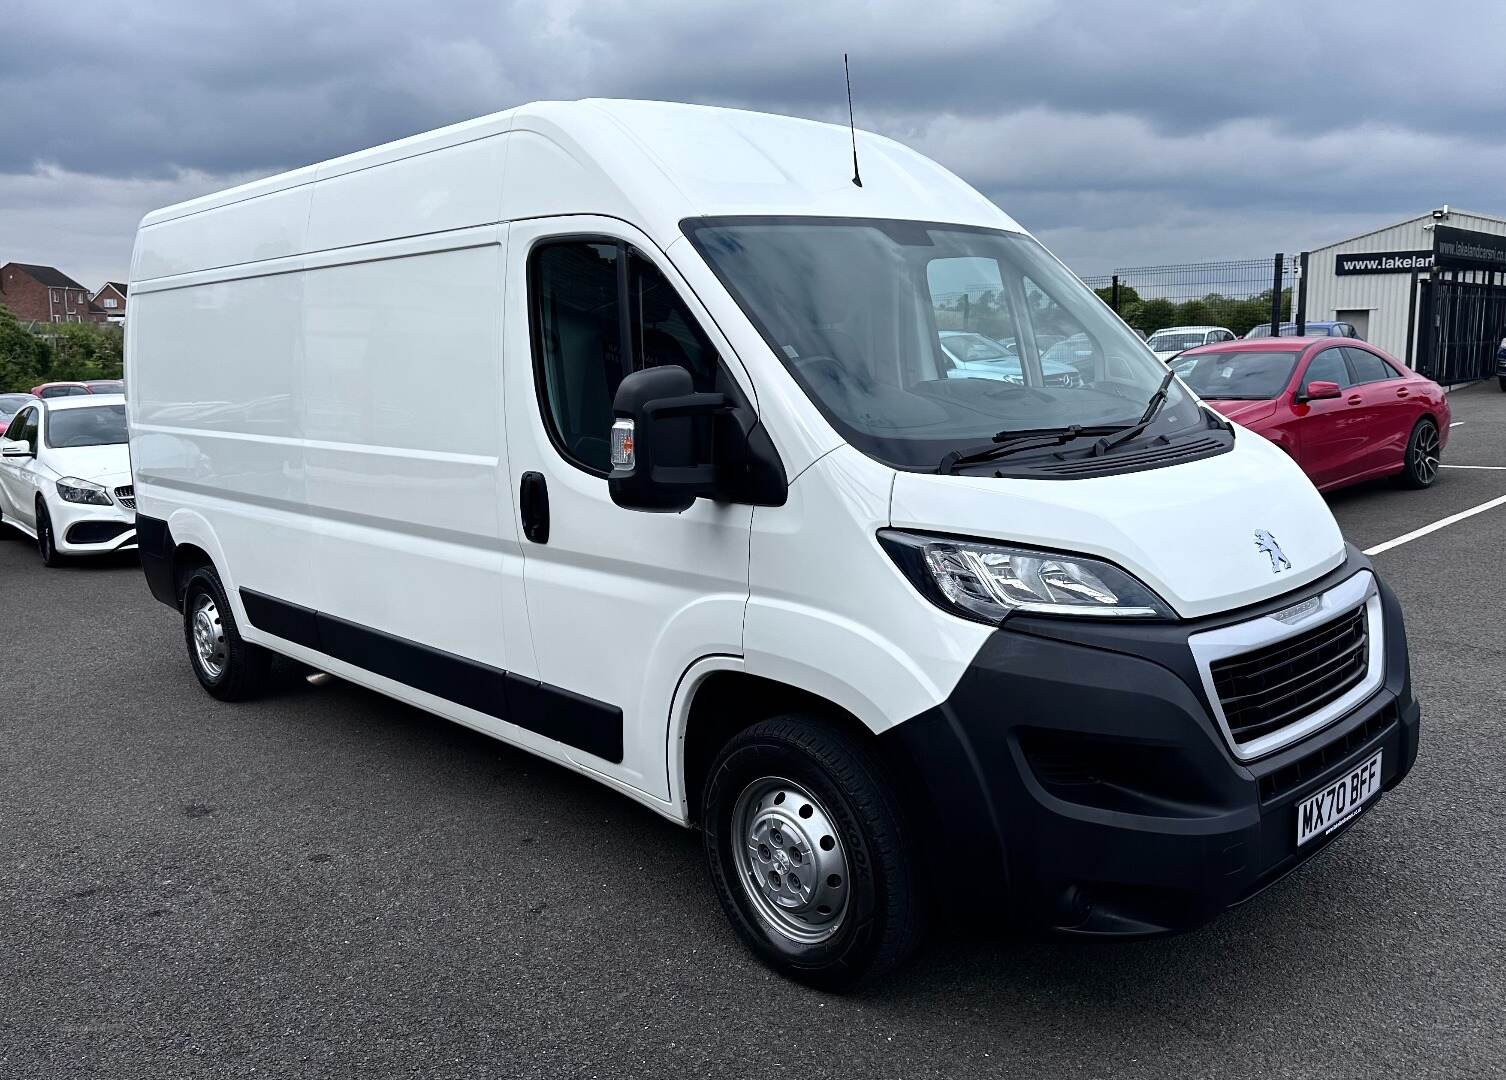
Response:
[744, 446, 992, 732]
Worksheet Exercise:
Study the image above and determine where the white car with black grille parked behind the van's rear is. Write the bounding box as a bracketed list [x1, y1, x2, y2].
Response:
[0, 393, 136, 566]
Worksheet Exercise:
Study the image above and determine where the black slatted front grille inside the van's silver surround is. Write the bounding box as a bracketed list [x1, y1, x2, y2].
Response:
[1209, 604, 1370, 744]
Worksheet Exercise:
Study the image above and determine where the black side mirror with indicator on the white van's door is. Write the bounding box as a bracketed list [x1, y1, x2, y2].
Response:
[607, 365, 730, 514]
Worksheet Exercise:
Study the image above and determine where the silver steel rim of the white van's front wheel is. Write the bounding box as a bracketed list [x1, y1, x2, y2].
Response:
[732, 776, 851, 944]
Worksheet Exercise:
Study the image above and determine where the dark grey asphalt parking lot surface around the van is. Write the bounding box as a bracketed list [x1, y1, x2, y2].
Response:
[0, 383, 1506, 1080]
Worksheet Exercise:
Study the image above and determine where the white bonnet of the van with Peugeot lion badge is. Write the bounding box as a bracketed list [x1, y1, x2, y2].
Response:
[893, 428, 1345, 619]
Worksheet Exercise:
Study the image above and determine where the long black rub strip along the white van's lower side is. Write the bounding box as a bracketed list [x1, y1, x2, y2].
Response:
[241, 589, 622, 762]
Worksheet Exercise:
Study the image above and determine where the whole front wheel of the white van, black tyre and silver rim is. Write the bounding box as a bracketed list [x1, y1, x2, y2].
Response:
[702, 714, 925, 990]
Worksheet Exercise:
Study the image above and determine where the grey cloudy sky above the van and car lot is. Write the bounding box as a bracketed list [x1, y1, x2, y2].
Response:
[0, 0, 1506, 286]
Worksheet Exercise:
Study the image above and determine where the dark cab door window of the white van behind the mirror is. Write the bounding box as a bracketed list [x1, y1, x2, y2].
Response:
[530, 239, 720, 476]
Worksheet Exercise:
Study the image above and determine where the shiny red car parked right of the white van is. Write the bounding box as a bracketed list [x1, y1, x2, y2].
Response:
[1172, 337, 1452, 491]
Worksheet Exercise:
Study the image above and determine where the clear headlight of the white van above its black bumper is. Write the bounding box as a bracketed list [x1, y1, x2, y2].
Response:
[878, 529, 1176, 625]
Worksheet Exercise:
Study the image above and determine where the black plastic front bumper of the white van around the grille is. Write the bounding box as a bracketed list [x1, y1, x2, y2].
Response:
[884, 550, 1420, 937]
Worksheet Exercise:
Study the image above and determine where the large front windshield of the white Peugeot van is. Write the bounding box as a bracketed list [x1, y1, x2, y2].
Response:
[684, 217, 1202, 470]
